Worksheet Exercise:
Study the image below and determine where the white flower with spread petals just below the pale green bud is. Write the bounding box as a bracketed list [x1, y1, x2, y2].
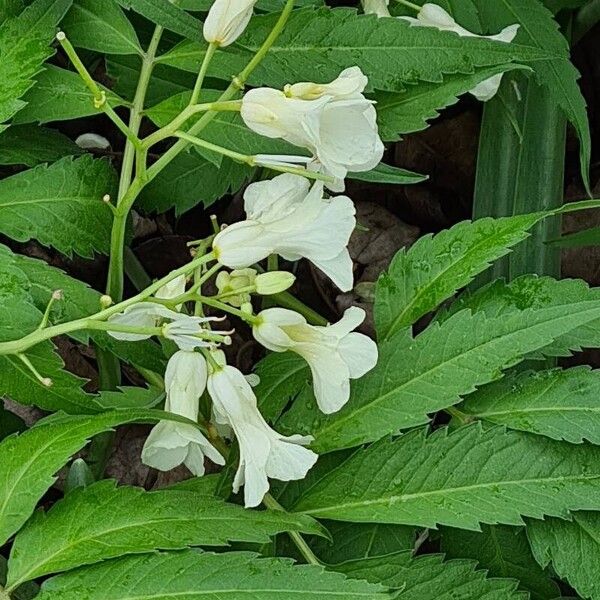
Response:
[252, 307, 377, 414]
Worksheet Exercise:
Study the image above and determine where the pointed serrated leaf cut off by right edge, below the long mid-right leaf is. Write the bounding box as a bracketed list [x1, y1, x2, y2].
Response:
[461, 366, 600, 444]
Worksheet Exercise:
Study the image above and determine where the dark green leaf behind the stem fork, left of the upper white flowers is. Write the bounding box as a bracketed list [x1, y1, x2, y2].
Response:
[140, 152, 252, 215]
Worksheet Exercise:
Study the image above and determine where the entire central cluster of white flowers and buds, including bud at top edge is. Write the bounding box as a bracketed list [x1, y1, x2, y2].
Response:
[108, 0, 384, 506]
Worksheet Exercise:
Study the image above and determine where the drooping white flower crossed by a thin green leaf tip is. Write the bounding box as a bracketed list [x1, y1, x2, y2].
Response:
[142, 350, 225, 476]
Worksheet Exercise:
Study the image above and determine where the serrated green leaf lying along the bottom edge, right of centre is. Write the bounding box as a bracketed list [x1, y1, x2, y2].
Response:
[340, 552, 527, 600]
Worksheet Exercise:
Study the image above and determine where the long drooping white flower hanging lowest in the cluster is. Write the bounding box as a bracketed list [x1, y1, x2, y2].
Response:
[208, 365, 317, 507]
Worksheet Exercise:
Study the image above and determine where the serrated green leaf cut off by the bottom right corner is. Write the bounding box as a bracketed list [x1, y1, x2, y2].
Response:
[527, 512, 600, 600]
